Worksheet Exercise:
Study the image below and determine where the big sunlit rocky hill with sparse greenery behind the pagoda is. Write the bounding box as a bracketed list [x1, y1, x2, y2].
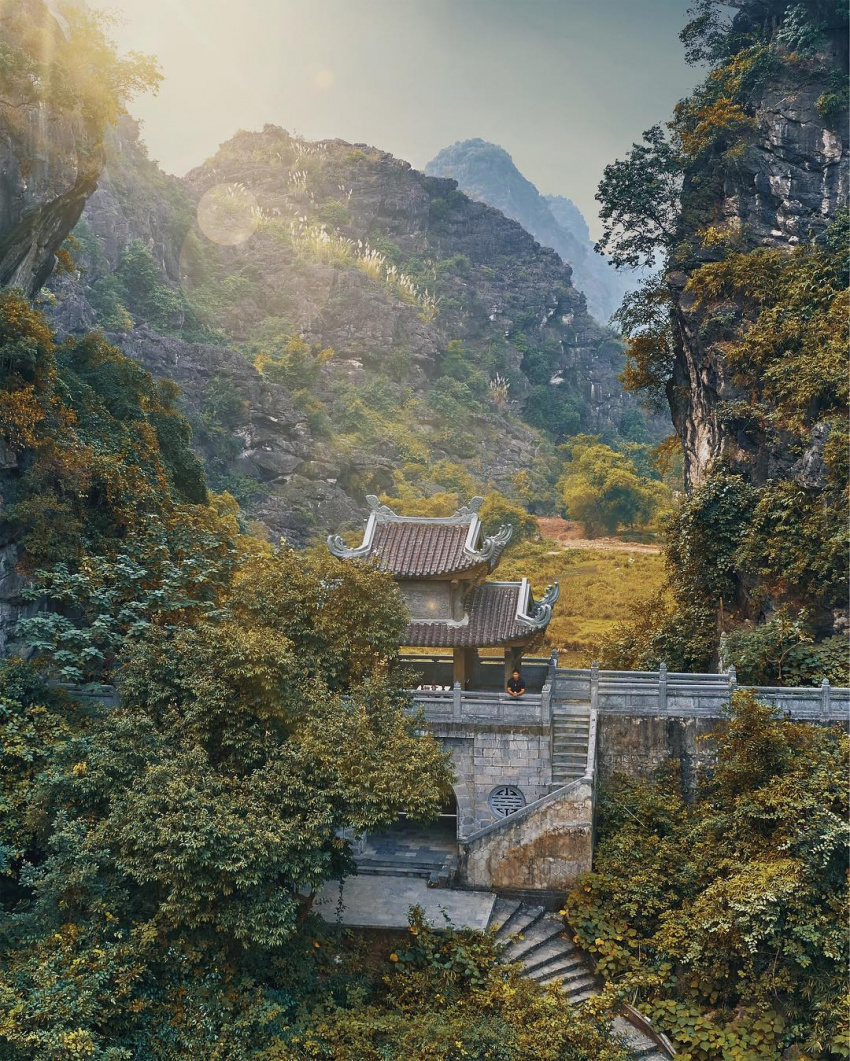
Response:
[51, 121, 657, 543]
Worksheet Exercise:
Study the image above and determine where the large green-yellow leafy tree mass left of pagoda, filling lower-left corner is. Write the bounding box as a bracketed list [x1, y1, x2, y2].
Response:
[0, 545, 450, 1061]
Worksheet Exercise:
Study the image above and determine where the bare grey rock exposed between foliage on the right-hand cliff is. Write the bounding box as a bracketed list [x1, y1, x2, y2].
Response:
[667, 31, 850, 487]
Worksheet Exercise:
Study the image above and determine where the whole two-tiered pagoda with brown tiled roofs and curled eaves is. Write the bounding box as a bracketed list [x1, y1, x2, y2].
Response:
[328, 495, 560, 689]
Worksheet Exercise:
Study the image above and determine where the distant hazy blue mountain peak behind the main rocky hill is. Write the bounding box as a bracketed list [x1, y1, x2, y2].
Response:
[426, 139, 634, 321]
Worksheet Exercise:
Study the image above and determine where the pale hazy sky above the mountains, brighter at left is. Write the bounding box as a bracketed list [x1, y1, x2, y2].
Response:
[99, 0, 698, 231]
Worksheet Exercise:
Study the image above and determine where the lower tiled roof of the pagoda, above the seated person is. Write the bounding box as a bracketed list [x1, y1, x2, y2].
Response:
[402, 578, 559, 648]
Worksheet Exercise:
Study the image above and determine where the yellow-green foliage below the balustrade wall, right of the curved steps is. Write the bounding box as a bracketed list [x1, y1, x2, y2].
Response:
[567, 693, 850, 1061]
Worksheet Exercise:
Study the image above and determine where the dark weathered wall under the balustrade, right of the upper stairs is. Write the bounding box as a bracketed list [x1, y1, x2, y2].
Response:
[599, 714, 721, 789]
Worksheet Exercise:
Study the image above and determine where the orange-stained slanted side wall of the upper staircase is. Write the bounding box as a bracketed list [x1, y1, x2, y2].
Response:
[461, 780, 593, 891]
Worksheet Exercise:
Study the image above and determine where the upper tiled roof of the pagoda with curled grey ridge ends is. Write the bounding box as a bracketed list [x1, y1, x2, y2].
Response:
[328, 494, 513, 578]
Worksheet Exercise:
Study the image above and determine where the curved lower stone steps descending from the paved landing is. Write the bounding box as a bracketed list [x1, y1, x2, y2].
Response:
[490, 895, 669, 1061]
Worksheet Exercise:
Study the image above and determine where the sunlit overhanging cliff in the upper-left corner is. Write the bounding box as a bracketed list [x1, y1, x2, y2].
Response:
[0, 0, 103, 295]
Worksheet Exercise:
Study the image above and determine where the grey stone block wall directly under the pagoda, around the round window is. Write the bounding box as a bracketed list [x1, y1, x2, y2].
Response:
[430, 723, 552, 838]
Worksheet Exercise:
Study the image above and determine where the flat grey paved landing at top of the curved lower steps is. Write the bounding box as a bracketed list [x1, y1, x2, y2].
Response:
[313, 875, 496, 930]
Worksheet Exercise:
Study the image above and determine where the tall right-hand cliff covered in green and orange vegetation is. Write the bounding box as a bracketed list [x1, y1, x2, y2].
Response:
[599, 0, 850, 683]
